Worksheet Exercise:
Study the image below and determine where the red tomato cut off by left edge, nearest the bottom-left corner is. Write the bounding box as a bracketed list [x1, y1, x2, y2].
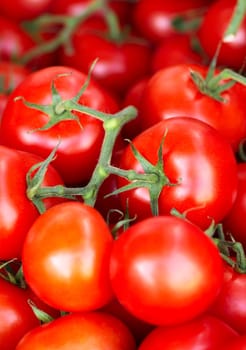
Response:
[0, 278, 40, 350]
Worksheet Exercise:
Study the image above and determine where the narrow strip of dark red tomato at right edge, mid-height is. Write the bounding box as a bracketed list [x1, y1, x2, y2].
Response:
[223, 163, 246, 248]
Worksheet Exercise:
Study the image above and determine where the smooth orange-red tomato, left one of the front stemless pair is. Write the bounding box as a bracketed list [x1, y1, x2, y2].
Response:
[22, 202, 113, 311]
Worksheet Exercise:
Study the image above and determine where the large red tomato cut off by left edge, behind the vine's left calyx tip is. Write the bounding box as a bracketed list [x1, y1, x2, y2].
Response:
[0, 146, 63, 260]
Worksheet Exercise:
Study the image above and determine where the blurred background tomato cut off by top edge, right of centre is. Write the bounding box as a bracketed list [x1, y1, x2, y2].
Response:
[132, 0, 212, 43]
